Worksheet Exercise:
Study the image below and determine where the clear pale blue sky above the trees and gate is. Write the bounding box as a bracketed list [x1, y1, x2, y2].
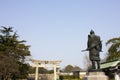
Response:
[0, 0, 120, 68]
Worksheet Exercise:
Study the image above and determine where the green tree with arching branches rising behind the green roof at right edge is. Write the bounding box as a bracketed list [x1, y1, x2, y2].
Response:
[106, 37, 120, 61]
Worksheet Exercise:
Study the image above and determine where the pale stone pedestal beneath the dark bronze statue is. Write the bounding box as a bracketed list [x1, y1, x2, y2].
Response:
[83, 72, 109, 80]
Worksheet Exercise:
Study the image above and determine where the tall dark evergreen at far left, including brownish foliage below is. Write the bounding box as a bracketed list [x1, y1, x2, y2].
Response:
[0, 26, 30, 80]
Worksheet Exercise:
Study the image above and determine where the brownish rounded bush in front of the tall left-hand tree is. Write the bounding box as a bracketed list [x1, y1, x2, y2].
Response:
[0, 52, 19, 80]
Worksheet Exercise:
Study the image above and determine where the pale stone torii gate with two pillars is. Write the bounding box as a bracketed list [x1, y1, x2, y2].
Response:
[31, 59, 61, 80]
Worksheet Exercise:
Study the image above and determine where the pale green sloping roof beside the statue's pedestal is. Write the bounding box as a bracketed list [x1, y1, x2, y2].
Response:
[100, 59, 120, 69]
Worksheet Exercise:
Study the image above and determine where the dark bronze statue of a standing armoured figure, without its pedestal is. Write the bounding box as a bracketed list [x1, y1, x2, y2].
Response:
[87, 30, 102, 69]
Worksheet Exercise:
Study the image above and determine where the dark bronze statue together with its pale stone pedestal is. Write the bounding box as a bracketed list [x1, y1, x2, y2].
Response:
[82, 30, 108, 80]
